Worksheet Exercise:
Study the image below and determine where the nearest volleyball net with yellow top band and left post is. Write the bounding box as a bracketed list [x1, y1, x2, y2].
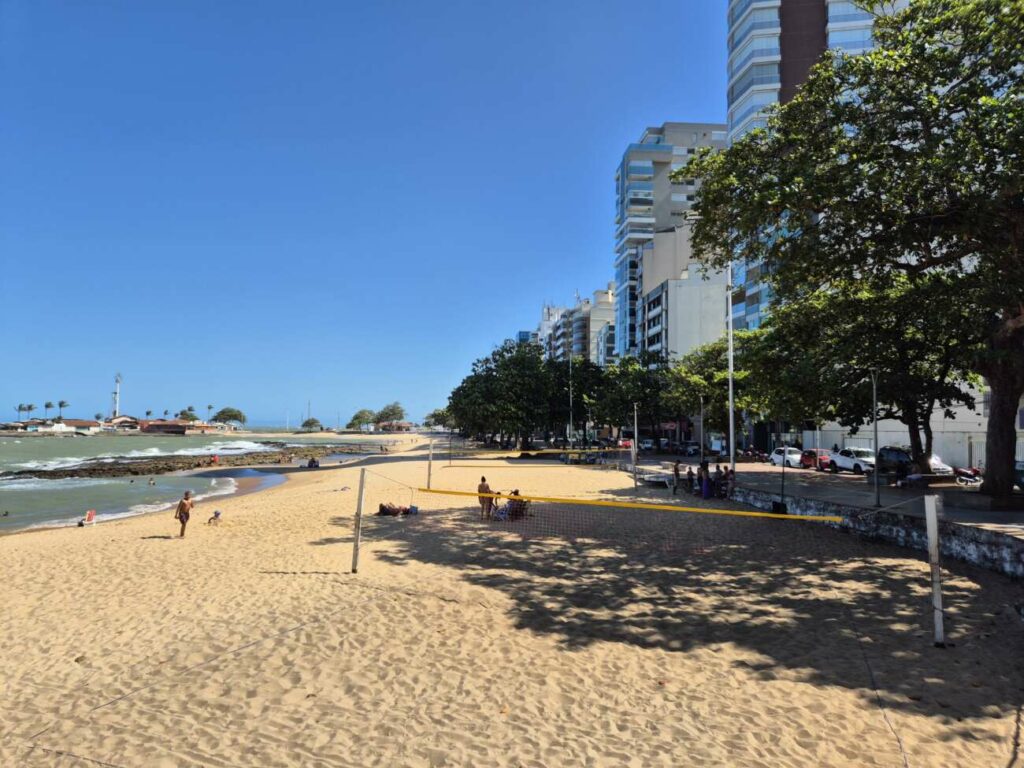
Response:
[352, 470, 844, 572]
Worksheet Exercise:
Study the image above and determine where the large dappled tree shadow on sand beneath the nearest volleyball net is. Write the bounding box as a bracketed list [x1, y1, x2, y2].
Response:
[311, 507, 1024, 724]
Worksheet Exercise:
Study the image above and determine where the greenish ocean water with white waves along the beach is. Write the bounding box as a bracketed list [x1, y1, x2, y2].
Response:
[0, 435, 376, 534]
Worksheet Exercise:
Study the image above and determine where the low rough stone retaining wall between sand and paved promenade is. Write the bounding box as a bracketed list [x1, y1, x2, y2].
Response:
[732, 486, 1024, 579]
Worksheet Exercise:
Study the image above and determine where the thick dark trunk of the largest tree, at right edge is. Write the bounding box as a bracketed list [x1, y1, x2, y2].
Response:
[981, 372, 1024, 497]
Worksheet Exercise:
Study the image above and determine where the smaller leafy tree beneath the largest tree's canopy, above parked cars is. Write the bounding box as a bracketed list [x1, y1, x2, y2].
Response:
[744, 276, 977, 466]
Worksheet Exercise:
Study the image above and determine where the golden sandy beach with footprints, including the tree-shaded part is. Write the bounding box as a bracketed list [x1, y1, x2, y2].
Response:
[0, 446, 1024, 768]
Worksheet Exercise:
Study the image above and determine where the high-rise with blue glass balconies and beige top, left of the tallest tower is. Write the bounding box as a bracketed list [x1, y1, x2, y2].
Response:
[614, 123, 726, 357]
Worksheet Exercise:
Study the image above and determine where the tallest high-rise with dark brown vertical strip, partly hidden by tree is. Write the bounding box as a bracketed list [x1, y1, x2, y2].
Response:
[728, 0, 909, 329]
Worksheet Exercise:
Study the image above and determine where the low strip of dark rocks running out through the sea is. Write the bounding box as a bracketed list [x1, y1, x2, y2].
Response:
[0, 443, 366, 479]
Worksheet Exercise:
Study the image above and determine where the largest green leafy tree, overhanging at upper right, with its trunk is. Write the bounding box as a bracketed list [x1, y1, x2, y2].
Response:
[684, 0, 1024, 496]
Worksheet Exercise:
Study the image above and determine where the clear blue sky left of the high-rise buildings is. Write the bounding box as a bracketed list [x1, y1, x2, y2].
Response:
[0, 0, 726, 424]
